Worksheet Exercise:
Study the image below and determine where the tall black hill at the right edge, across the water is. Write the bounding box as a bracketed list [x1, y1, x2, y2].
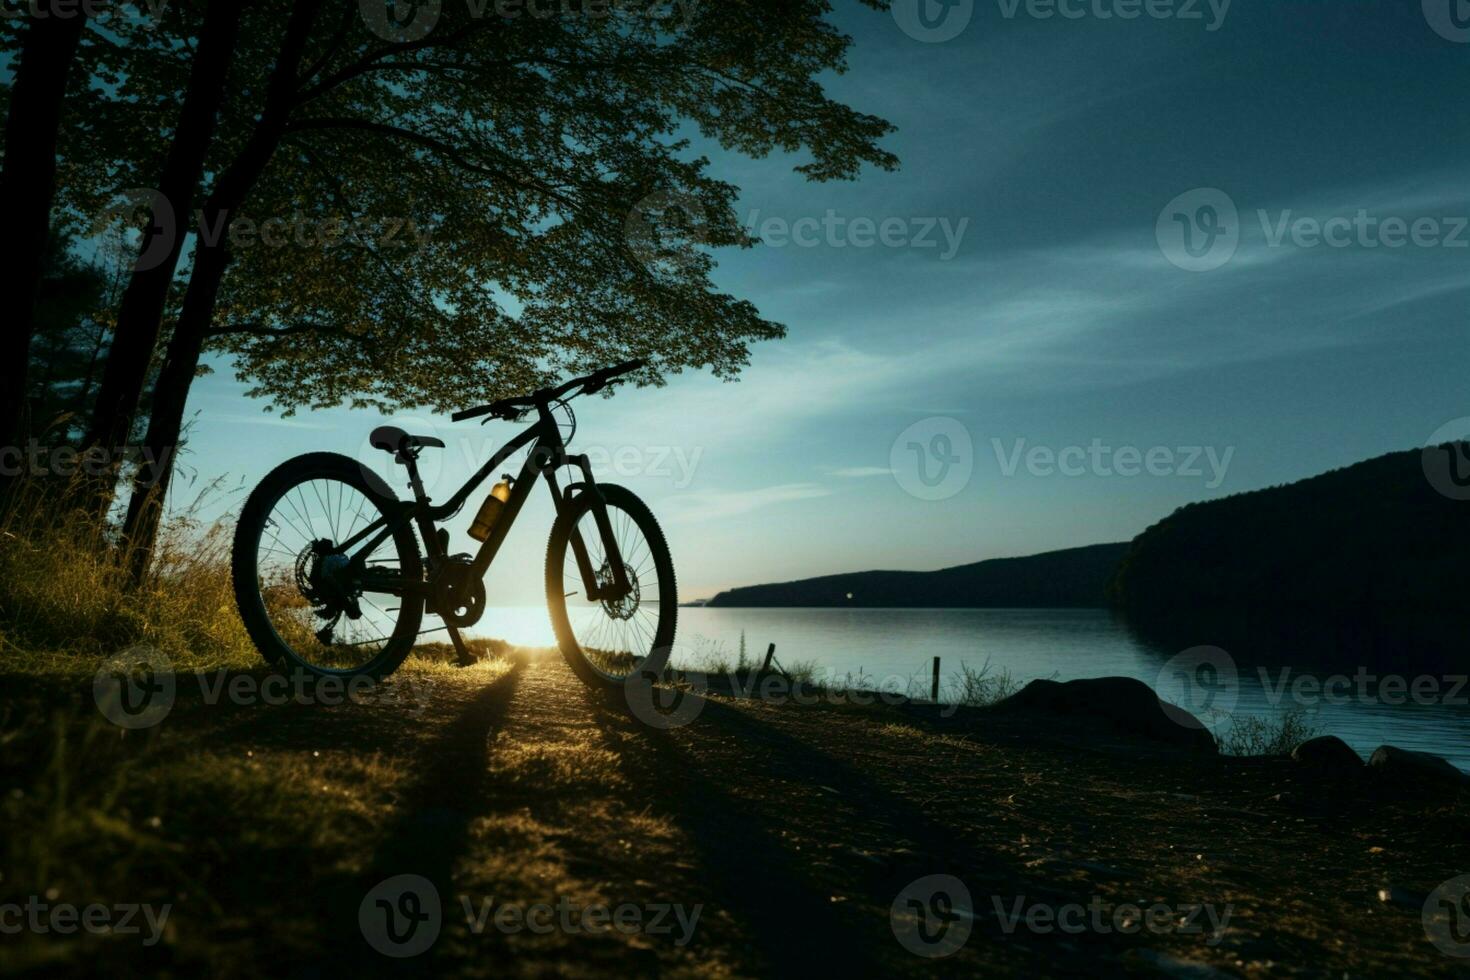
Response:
[1108, 450, 1470, 614]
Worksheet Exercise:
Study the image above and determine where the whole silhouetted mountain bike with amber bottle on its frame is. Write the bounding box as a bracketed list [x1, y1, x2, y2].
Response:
[232, 360, 678, 688]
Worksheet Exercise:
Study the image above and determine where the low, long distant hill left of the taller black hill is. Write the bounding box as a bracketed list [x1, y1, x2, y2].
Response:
[707, 542, 1129, 608]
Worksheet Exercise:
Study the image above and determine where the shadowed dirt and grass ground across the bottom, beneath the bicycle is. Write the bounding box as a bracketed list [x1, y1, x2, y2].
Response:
[3, 646, 1470, 976]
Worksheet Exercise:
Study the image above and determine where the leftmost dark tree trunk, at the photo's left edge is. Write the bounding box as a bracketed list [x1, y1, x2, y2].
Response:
[0, 4, 87, 467]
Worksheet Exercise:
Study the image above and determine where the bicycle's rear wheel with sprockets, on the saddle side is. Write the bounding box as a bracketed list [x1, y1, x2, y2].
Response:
[234, 453, 423, 677]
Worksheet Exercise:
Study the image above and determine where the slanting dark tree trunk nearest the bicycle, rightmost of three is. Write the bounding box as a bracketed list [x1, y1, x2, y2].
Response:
[123, 0, 322, 585]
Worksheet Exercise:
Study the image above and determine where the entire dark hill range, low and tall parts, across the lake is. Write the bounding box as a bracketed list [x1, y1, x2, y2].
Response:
[706, 448, 1470, 614]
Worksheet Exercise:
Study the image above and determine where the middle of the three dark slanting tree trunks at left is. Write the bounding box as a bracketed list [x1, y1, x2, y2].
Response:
[87, 0, 241, 513]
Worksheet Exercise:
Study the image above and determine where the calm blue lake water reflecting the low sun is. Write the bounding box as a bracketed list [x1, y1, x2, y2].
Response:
[476, 607, 1470, 770]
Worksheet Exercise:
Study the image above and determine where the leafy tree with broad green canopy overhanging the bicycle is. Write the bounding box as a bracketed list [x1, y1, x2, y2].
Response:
[63, 1, 895, 578]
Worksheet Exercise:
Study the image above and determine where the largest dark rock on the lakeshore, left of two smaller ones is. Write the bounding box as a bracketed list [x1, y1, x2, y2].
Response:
[995, 677, 1219, 755]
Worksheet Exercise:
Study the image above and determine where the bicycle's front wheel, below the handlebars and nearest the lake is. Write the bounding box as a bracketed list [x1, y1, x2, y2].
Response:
[547, 483, 679, 688]
